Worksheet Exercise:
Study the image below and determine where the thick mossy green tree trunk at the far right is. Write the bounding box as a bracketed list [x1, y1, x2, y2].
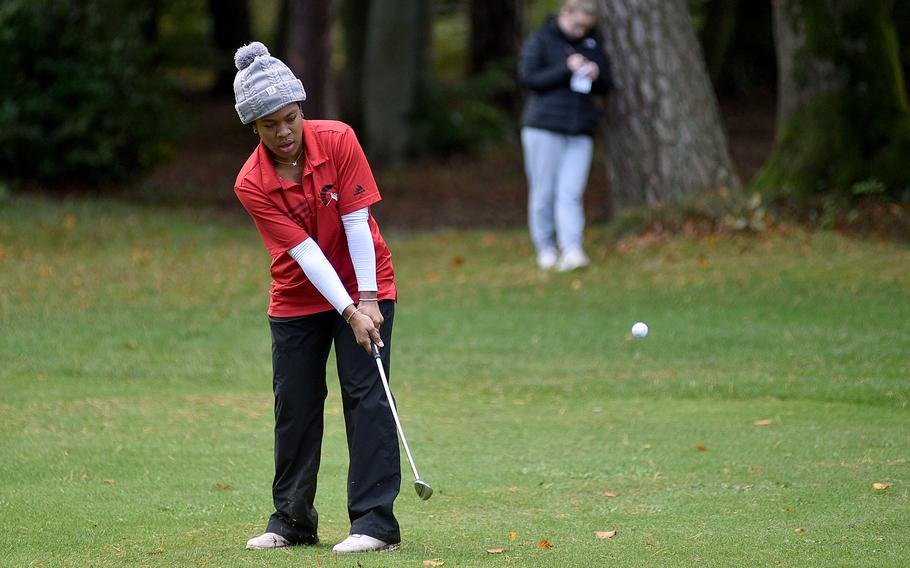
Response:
[753, 0, 910, 195]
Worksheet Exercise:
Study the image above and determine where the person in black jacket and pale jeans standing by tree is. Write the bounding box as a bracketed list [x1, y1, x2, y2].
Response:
[518, 0, 612, 271]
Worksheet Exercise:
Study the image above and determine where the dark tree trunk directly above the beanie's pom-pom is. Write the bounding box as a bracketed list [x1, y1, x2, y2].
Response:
[207, 0, 253, 96]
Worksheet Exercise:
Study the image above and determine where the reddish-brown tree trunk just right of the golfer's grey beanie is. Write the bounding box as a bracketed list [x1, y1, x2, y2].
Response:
[286, 0, 338, 119]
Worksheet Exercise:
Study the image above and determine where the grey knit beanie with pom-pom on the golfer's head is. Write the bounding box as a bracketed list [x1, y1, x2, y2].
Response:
[234, 41, 306, 124]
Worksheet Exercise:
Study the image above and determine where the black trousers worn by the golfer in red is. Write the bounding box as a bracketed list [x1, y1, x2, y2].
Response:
[267, 300, 401, 544]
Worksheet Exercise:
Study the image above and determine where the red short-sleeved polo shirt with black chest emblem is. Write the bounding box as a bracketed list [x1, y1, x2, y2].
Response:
[234, 120, 398, 317]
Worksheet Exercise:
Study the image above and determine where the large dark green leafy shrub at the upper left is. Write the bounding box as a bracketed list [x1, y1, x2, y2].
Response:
[0, 0, 173, 185]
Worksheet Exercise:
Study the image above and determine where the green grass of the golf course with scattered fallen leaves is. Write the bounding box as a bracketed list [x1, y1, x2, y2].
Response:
[0, 198, 910, 567]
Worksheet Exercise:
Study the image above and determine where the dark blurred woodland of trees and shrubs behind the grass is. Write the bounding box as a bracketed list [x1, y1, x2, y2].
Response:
[0, 0, 910, 225]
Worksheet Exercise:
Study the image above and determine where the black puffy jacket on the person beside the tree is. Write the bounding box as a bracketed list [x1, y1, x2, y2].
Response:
[518, 16, 613, 134]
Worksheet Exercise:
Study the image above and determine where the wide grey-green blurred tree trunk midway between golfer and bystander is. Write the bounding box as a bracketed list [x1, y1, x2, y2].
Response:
[361, 0, 429, 164]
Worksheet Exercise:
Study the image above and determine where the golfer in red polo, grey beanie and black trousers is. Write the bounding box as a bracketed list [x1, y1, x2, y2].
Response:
[234, 42, 401, 553]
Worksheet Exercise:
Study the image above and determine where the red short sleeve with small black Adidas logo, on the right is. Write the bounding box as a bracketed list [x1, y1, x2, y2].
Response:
[333, 128, 382, 215]
